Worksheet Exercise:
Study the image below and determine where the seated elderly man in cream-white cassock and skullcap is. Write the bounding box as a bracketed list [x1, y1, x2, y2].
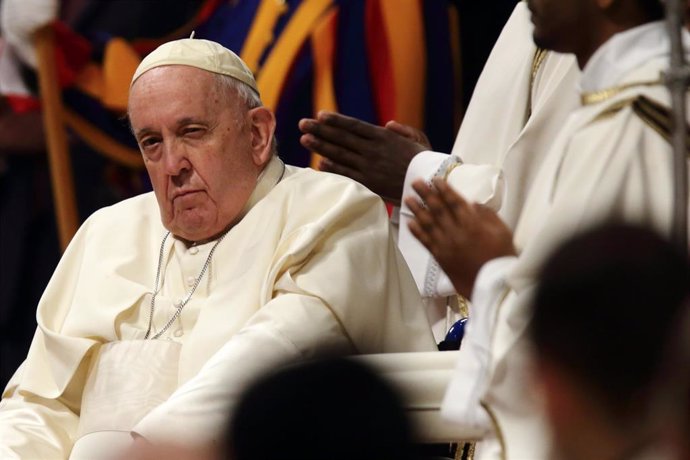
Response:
[0, 39, 435, 459]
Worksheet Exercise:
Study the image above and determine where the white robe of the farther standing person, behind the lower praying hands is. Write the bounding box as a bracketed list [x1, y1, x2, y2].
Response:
[398, 2, 580, 341]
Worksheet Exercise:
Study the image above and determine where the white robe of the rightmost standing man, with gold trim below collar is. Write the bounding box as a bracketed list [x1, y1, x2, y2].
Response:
[444, 22, 690, 460]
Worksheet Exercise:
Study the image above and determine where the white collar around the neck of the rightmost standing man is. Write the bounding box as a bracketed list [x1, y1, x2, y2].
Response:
[580, 21, 690, 92]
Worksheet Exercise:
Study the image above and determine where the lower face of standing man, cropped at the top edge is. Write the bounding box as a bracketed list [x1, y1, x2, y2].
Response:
[527, 0, 591, 53]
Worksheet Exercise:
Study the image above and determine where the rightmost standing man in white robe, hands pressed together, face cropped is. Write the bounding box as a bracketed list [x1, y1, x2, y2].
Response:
[407, 0, 690, 459]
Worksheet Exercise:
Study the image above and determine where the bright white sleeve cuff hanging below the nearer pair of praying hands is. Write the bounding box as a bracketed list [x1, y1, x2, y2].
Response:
[441, 257, 517, 430]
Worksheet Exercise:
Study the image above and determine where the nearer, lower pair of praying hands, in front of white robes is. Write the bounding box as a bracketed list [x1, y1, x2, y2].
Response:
[405, 179, 516, 298]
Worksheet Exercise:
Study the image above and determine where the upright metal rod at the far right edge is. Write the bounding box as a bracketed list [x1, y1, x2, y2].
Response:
[665, 0, 690, 253]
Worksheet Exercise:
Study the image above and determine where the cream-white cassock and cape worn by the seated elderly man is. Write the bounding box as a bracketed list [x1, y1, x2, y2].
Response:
[0, 158, 435, 459]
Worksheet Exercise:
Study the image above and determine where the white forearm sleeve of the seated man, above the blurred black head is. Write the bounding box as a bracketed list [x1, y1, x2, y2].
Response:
[132, 294, 353, 445]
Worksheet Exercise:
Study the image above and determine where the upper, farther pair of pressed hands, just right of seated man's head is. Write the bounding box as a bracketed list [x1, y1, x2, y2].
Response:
[299, 111, 430, 204]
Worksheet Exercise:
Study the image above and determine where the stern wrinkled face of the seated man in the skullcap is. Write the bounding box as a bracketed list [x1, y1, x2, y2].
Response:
[129, 66, 268, 241]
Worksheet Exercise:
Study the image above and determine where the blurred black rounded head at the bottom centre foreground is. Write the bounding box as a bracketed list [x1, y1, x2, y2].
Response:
[228, 359, 412, 460]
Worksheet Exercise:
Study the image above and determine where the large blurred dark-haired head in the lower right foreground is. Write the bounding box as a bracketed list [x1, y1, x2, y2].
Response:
[530, 225, 690, 460]
